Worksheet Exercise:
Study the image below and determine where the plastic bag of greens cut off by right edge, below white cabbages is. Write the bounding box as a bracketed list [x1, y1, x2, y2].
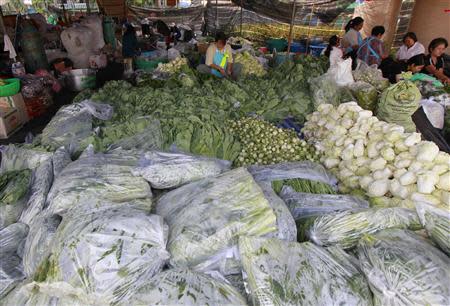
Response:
[416, 203, 450, 256]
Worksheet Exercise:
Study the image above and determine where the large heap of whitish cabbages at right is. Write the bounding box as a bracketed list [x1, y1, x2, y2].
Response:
[303, 102, 450, 207]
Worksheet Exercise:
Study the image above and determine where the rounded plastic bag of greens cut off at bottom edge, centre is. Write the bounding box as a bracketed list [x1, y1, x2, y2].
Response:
[123, 269, 247, 305]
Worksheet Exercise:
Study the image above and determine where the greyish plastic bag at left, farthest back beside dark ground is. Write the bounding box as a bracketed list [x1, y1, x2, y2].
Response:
[41, 100, 113, 154]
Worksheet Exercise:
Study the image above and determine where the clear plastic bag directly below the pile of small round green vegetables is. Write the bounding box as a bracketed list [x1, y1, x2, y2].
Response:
[248, 161, 337, 188]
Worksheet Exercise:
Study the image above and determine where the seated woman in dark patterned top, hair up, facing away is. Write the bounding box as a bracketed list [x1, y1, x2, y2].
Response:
[357, 26, 388, 66]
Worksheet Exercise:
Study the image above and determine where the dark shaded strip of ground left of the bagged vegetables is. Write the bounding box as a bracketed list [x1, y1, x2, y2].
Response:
[0, 89, 77, 145]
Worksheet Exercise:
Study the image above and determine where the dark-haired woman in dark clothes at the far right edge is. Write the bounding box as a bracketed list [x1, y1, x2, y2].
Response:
[422, 37, 450, 84]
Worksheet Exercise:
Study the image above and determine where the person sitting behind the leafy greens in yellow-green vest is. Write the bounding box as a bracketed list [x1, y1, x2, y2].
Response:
[197, 32, 242, 79]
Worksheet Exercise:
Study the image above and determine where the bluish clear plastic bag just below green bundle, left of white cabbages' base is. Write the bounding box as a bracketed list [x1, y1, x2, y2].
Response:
[280, 186, 369, 220]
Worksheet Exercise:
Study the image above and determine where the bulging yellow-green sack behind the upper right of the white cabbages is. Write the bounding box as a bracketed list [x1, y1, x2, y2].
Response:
[377, 81, 422, 132]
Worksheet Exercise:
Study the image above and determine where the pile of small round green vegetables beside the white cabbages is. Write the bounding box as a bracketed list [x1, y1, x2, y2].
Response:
[230, 118, 319, 166]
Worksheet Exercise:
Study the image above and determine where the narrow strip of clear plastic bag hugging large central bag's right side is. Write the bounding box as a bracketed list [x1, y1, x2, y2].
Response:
[258, 181, 297, 241]
